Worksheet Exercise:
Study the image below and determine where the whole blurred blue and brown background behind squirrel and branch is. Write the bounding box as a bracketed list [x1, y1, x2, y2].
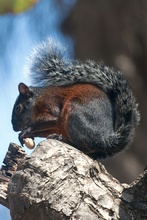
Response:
[0, 0, 147, 220]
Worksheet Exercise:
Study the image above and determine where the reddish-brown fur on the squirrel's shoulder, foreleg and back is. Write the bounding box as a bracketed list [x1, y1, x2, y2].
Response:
[32, 84, 106, 140]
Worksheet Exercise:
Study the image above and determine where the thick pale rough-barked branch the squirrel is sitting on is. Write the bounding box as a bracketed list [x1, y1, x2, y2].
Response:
[4, 140, 147, 220]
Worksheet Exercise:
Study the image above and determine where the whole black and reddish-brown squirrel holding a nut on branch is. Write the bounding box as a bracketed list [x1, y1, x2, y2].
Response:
[12, 41, 140, 159]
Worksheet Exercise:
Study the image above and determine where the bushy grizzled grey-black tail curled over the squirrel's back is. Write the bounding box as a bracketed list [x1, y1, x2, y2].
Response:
[27, 40, 140, 155]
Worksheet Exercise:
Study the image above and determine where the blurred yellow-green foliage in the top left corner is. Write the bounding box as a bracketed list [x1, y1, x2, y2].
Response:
[0, 0, 38, 14]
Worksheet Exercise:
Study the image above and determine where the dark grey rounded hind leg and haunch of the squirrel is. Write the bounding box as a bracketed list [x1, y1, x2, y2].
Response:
[68, 97, 114, 159]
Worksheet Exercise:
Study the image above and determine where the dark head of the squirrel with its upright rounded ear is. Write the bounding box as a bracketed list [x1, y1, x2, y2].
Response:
[12, 83, 33, 131]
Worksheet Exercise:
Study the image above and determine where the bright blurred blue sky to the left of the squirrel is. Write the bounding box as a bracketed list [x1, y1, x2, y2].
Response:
[0, 0, 74, 220]
